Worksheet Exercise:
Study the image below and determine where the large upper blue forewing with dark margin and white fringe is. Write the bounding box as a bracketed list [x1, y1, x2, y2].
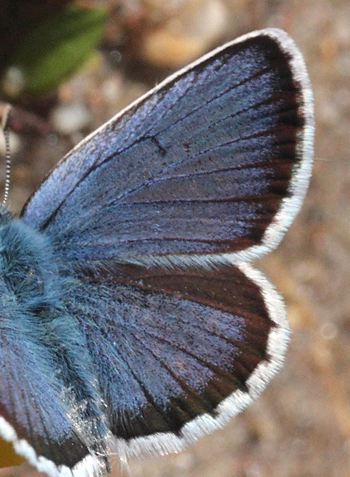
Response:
[23, 30, 313, 262]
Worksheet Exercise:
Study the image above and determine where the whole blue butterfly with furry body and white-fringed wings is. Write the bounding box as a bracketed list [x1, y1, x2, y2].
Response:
[0, 29, 314, 477]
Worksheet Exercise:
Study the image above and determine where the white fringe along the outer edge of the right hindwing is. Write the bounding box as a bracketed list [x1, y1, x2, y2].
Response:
[111, 262, 290, 461]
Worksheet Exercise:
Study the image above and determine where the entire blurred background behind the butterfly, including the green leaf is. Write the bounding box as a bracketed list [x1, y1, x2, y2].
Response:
[0, 0, 350, 477]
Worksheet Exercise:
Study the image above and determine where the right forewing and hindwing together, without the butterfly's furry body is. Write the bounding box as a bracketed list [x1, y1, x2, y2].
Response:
[22, 29, 313, 456]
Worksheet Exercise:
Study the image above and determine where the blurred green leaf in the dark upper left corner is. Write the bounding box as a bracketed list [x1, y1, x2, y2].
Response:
[8, 6, 106, 96]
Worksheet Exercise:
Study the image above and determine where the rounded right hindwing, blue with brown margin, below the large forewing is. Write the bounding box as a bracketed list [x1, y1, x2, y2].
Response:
[67, 263, 288, 454]
